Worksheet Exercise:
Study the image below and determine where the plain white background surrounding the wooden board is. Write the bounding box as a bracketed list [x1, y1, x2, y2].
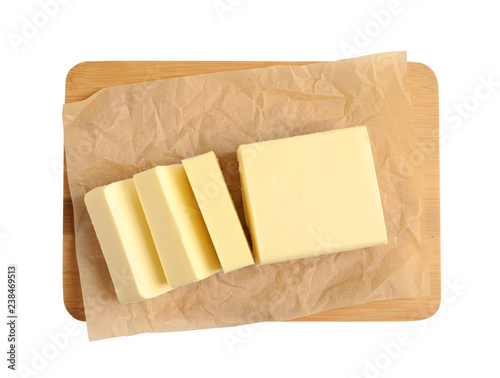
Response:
[0, 0, 500, 378]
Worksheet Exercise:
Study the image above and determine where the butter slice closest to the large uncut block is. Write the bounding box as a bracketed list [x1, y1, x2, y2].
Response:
[182, 152, 254, 273]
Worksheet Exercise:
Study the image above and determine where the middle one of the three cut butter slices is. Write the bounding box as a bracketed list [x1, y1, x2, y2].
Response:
[134, 164, 221, 287]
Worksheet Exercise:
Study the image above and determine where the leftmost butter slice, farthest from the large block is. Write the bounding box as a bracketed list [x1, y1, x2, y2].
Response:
[85, 179, 171, 303]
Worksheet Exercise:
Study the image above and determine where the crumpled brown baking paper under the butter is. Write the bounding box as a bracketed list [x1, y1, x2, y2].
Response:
[63, 52, 430, 340]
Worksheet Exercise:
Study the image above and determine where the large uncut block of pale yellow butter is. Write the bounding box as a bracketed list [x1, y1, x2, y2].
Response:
[238, 126, 387, 264]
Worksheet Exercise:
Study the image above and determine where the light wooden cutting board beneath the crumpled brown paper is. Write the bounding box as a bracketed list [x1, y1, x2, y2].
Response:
[63, 61, 441, 321]
